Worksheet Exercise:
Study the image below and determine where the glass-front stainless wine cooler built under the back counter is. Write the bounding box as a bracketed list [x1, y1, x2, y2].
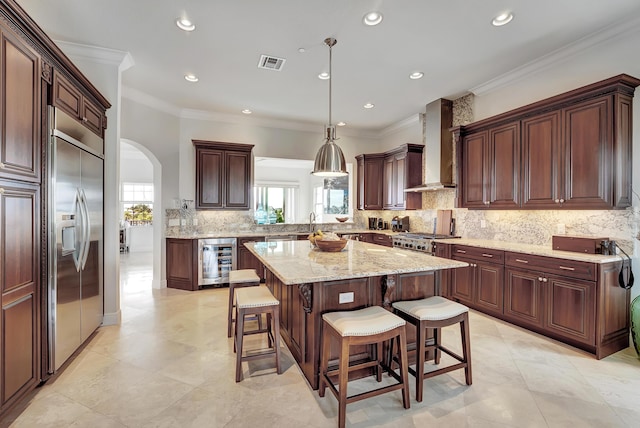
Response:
[198, 238, 237, 287]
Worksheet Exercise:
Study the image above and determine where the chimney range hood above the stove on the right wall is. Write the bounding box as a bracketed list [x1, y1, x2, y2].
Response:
[404, 98, 456, 192]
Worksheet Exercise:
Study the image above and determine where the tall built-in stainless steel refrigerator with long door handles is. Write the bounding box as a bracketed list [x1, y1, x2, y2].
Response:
[48, 108, 104, 373]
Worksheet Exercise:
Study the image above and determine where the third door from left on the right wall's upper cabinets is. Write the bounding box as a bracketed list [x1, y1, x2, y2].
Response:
[522, 112, 562, 208]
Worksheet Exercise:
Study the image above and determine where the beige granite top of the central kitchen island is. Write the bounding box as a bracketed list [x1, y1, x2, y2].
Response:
[245, 240, 467, 285]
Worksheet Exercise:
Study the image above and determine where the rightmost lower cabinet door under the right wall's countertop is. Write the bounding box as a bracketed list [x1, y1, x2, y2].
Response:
[545, 275, 596, 345]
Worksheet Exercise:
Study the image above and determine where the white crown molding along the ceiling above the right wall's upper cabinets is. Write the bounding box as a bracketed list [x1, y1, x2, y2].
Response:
[469, 13, 640, 96]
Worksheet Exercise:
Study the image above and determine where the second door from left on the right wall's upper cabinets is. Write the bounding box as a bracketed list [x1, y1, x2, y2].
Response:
[488, 123, 520, 208]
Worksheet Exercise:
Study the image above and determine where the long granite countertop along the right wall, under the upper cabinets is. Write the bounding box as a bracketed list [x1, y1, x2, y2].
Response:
[436, 238, 622, 263]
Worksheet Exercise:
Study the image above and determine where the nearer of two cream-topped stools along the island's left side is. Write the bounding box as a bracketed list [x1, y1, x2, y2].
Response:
[234, 286, 280, 382]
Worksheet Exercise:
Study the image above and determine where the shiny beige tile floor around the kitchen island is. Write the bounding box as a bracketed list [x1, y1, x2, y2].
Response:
[5, 253, 640, 428]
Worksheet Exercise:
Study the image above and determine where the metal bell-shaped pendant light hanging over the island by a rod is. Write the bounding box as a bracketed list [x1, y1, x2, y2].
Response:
[312, 38, 348, 177]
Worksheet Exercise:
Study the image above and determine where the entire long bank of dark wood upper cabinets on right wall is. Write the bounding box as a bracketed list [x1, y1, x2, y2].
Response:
[454, 75, 640, 209]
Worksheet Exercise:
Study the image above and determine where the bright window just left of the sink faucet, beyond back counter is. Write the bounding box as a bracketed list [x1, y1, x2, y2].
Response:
[253, 183, 298, 224]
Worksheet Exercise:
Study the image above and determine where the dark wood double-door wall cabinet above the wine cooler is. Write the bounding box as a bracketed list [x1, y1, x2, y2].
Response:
[193, 140, 253, 210]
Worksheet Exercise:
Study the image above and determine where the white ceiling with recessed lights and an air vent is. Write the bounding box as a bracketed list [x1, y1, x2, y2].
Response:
[18, 0, 640, 130]
